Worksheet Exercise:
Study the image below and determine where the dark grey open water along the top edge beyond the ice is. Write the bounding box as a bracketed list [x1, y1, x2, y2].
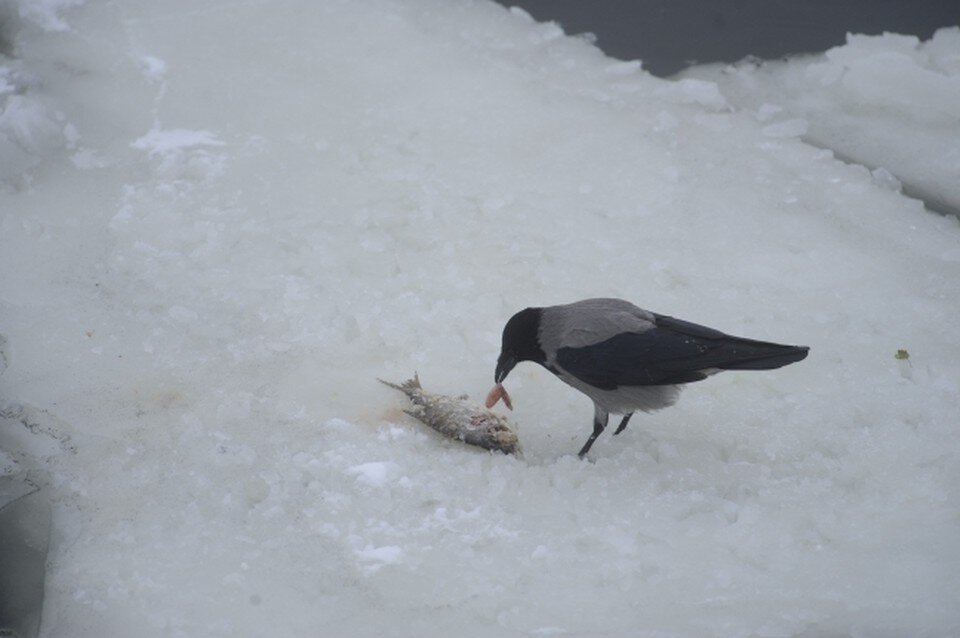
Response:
[497, 0, 960, 77]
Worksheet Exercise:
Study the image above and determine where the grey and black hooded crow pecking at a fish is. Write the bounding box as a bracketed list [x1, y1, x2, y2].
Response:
[494, 299, 809, 458]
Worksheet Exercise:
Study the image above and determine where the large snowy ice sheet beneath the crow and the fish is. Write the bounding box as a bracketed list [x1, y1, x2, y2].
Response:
[0, 0, 960, 638]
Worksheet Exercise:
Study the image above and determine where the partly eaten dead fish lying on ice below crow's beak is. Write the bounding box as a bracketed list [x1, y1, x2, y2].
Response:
[377, 375, 520, 454]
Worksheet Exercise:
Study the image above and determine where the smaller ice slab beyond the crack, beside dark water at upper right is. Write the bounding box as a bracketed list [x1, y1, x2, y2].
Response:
[680, 26, 960, 215]
